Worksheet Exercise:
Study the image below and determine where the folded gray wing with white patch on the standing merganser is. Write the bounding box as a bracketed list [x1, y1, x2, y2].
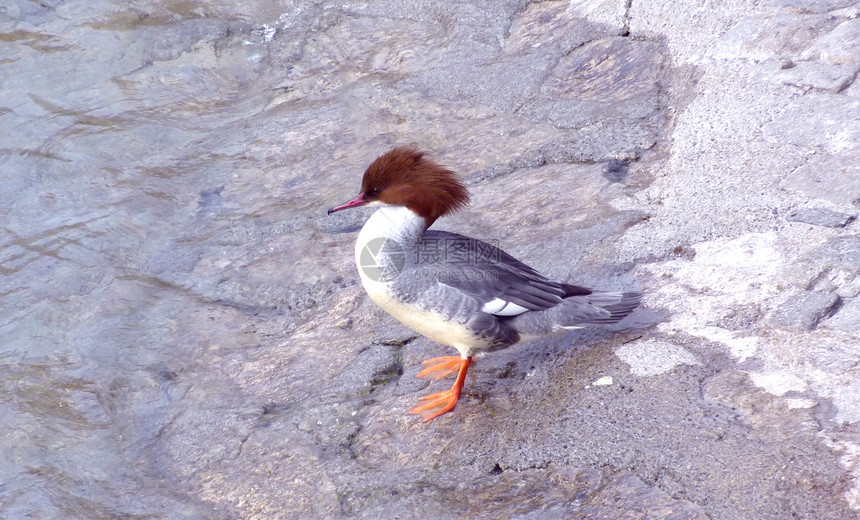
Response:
[413, 231, 592, 316]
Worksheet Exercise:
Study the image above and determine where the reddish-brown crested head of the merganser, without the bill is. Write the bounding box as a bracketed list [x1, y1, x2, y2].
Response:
[361, 146, 469, 227]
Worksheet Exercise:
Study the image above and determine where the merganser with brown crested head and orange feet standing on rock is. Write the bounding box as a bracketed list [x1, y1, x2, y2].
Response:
[328, 147, 642, 422]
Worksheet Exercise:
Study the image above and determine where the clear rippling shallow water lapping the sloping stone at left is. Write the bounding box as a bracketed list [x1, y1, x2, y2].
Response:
[0, 0, 316, 519]
